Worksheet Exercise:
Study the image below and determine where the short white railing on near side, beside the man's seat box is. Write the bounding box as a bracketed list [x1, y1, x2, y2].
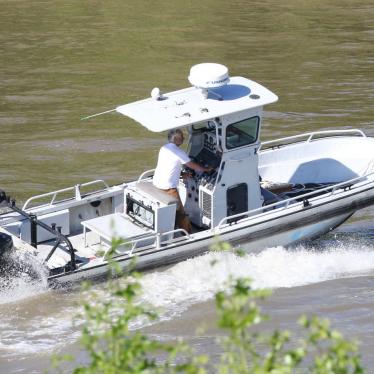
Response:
[115, 229, 191, 257]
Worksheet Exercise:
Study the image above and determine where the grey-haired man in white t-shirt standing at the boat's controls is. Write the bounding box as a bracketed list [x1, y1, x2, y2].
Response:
[153, 129, 211, 233]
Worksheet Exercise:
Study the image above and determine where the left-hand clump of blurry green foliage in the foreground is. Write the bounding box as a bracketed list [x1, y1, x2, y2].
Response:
[74, 274, 206, 374]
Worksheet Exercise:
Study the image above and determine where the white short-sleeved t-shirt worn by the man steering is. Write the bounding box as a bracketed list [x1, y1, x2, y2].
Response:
[153, 143, 191, 190]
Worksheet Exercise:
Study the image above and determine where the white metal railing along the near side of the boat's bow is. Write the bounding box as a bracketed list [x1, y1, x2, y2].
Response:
[216, 172, 374, 230]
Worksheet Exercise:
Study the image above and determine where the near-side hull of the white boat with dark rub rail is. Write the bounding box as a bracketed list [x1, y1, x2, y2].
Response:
[50, 181, 374, 284]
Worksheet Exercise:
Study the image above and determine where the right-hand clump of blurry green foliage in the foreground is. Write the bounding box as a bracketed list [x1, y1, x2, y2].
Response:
[216, 278, 364, 374]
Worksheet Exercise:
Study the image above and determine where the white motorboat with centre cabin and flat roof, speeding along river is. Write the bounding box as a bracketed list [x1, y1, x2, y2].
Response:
[0, 63, 374, 285]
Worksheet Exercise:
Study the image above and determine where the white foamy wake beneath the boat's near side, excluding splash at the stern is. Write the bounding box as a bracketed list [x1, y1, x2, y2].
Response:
[142, 242, 374, 319]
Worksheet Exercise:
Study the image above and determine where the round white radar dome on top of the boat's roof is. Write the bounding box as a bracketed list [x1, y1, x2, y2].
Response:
[188, 63, 230, 89]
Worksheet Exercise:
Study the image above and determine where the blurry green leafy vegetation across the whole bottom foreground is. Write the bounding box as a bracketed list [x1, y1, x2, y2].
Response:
[53, 242, 364, 374]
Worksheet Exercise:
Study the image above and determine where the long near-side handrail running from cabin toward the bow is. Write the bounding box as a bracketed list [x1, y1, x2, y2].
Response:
[215, 172, 374, 229]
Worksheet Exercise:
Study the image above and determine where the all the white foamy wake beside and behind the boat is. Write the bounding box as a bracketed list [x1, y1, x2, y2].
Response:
[0, 241, 374, 358]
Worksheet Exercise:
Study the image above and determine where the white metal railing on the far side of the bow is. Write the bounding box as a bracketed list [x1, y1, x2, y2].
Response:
[259, 129, 366, 151]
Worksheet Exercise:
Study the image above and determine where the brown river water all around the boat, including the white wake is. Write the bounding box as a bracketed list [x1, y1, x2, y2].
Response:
[0, 0, 374, 373]
